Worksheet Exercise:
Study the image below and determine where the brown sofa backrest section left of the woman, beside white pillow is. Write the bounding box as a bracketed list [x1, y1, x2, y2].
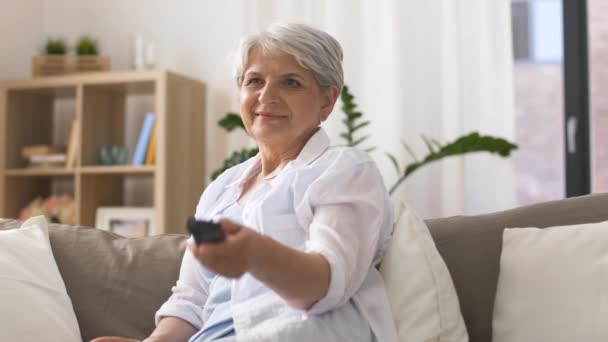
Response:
[0, 220, 187, 341]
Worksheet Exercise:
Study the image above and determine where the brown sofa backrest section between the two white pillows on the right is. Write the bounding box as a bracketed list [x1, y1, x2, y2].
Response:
[427, 194, 608, 342]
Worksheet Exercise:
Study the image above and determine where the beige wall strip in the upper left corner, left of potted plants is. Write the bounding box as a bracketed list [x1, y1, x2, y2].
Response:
[0, 0, 44, 80]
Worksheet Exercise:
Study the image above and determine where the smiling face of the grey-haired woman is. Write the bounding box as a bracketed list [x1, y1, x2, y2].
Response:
[240, 49, 338, 147]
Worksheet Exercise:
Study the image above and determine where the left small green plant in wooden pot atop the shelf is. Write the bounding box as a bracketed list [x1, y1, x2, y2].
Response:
[32, 38, 68, 77]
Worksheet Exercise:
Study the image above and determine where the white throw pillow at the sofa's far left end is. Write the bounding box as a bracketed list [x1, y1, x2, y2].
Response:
[0, 216, 82, 342]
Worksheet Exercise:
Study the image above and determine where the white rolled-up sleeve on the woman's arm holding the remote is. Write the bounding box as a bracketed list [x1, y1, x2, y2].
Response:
[306, 162, 387, 314]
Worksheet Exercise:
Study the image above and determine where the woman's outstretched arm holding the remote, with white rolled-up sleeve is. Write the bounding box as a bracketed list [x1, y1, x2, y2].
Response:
[190, 164, 388, 313]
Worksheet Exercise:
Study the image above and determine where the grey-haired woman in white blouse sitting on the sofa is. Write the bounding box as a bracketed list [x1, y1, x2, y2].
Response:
[96, 25, 397, 342]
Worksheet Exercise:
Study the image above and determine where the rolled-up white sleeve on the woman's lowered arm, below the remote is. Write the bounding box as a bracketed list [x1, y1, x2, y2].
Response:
[155, 236, 209, 329]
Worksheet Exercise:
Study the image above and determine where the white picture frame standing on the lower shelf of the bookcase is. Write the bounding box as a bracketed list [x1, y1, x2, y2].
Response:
[95, 207, 157, 238]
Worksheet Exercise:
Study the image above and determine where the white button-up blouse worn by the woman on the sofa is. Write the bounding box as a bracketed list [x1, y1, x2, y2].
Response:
[156, 129, 397, 342]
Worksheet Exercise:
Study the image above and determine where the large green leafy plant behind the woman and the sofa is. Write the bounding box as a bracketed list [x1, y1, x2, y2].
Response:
[211, 86, 517, 194]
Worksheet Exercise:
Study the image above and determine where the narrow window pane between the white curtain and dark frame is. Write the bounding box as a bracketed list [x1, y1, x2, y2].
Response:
[512, 0, 565, 205]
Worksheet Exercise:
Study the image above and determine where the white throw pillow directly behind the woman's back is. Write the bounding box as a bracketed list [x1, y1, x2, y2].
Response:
[380, 202, 468, 342]
